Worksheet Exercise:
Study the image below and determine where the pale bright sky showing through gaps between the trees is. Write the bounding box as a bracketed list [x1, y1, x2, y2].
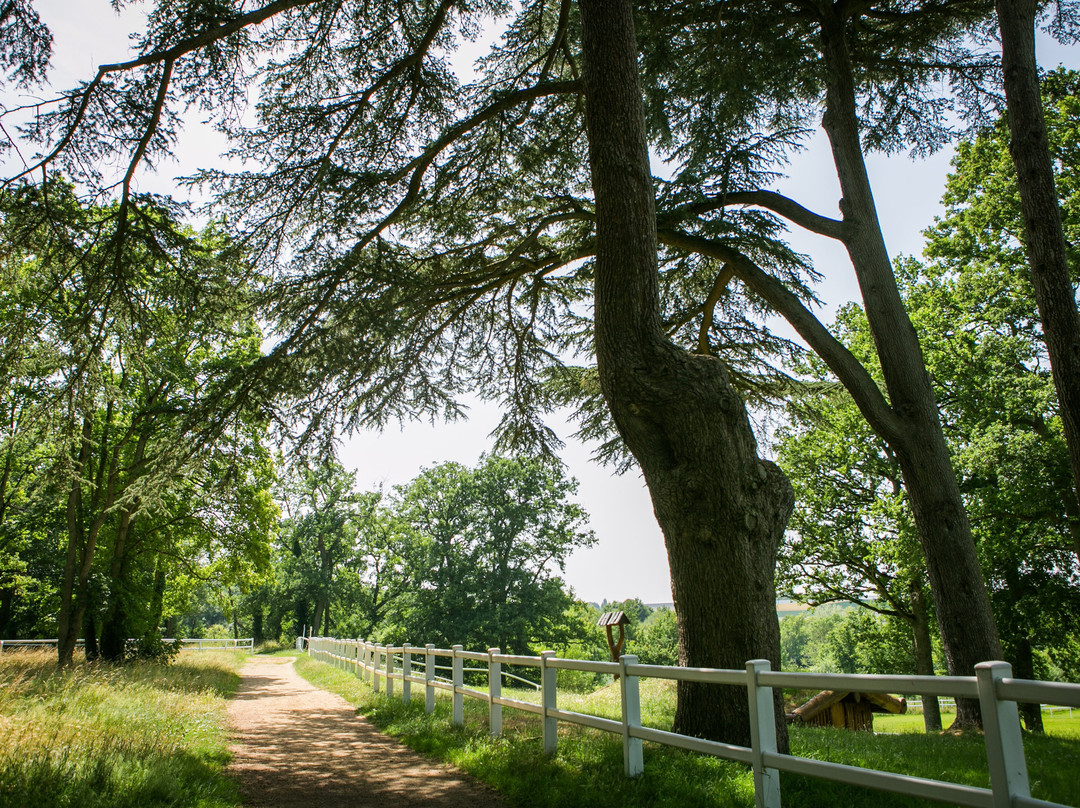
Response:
[6, 0, 1080, 603]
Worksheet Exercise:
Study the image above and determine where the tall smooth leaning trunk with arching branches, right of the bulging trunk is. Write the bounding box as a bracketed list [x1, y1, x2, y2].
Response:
[822, 6, 1001, 728]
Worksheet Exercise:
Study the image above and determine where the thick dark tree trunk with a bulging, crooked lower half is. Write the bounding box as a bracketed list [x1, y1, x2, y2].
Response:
[580, 0, 793, 749]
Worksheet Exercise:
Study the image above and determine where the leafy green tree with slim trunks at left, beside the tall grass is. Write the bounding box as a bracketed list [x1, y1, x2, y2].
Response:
[2, 179, 274, 664]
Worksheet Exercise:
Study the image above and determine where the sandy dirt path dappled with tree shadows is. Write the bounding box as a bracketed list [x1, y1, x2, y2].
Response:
[229, 657, 503, 808]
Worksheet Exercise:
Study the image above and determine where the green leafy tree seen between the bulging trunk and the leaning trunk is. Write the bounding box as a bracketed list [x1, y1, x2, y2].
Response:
[778, 343, 942, 731]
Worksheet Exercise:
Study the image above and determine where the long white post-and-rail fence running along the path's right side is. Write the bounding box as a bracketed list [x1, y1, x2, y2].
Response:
[297, 637, 1080, 808]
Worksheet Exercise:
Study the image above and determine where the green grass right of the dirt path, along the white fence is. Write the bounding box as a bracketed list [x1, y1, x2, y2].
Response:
[297, 655, 1080, 808]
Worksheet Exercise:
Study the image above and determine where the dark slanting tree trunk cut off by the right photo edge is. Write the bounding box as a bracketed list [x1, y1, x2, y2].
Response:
[996, 0, 1080, 555]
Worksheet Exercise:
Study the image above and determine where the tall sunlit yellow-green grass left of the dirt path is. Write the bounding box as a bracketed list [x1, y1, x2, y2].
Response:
[0, 651, 243, 808]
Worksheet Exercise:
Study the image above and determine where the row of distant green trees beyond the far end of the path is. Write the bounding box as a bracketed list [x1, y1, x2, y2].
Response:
[222, 456, 594, 654]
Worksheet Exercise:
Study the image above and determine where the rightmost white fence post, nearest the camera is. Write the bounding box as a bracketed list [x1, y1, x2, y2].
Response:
[975, 662, 1031, 808]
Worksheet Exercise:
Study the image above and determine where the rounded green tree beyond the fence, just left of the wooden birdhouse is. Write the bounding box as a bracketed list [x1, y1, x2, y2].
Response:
[386, 457, 594, 654]
